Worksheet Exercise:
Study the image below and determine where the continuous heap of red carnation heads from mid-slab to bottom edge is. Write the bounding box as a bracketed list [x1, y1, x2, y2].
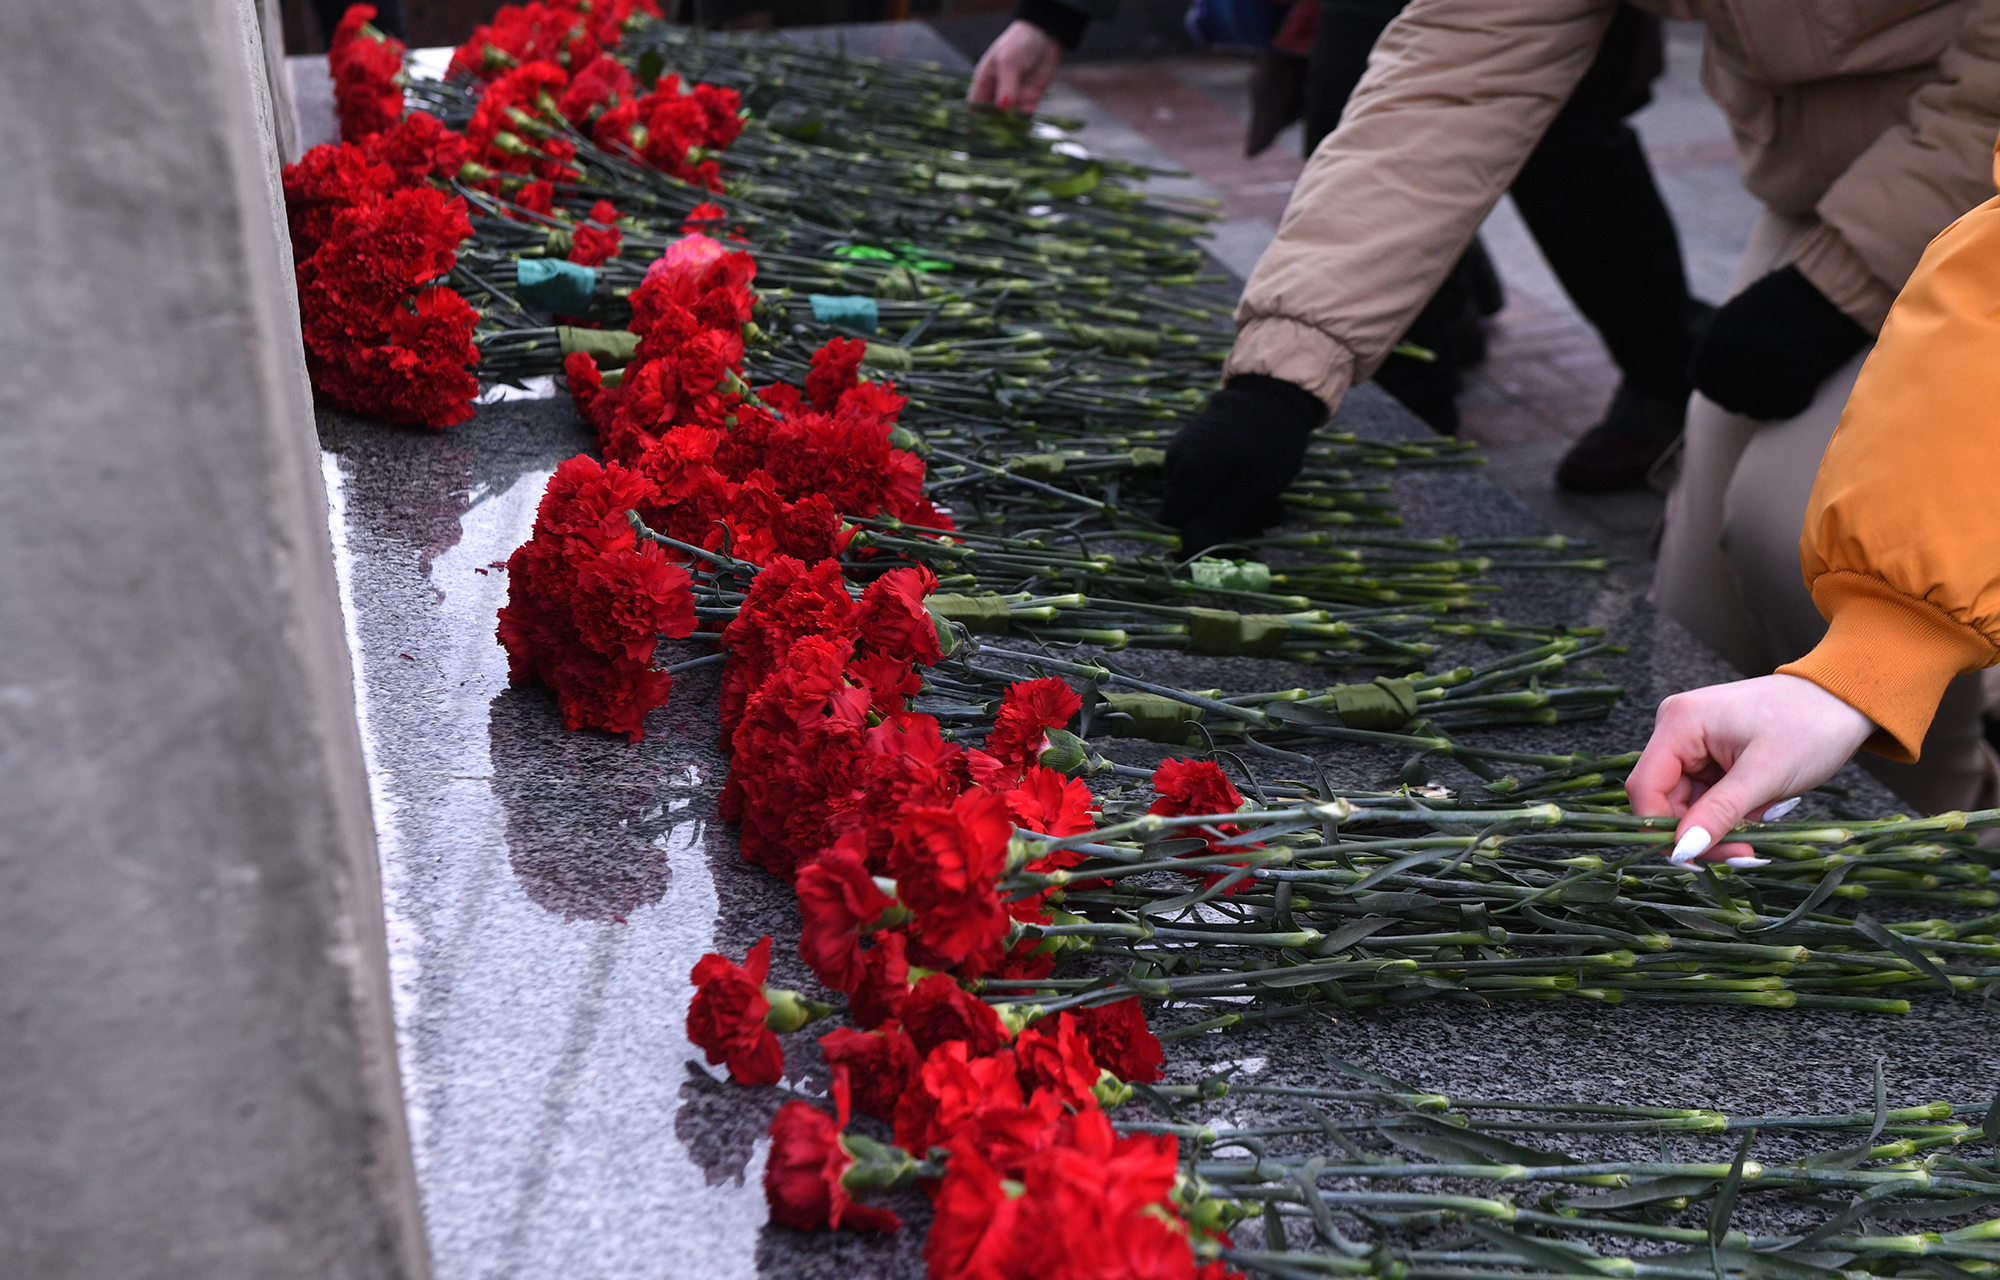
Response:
[488, 212, 1240, 1278]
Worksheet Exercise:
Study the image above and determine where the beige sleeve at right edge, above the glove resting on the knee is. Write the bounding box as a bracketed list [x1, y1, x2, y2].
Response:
[1792, 0, 2000, 332]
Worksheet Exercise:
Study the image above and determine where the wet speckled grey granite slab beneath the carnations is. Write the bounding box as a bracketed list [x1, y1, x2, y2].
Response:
[322, 376, 2000, 1280]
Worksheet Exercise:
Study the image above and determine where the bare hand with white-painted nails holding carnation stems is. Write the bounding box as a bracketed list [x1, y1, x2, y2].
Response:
[1626, 676, 1876, 866]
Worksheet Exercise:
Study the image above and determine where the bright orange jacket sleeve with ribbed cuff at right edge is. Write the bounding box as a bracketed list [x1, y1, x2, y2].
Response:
[1778, 180, 2000, 762]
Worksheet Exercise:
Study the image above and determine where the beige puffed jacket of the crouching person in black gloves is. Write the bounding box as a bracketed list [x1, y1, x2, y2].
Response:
[1224, 0, 2000, 406]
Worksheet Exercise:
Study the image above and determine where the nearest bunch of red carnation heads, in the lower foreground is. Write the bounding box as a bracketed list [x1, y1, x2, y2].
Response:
[688, 560, 1228, 1280]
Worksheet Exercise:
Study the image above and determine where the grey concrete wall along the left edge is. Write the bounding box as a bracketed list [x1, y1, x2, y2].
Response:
[0, 0, 426, 1280]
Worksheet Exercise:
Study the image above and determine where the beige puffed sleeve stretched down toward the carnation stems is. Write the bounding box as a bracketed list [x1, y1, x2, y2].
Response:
[1224, 0, 1616, 408]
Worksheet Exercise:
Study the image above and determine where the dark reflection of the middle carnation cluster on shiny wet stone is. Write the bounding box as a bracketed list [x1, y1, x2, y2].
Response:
[488, 688, 688, 920]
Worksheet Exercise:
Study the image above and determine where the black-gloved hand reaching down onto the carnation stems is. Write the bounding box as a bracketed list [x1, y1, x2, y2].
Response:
[1160, 374, 1326, 554]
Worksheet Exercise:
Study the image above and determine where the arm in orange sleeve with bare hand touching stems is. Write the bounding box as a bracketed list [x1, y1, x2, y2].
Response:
[1626, 178, 2000, 858]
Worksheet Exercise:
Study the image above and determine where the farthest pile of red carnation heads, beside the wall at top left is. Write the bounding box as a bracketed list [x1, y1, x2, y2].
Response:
[284, 0, 748, 430]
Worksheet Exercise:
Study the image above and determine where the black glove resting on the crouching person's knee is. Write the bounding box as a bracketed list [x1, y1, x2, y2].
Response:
[1688, 266, 1870, 422]
